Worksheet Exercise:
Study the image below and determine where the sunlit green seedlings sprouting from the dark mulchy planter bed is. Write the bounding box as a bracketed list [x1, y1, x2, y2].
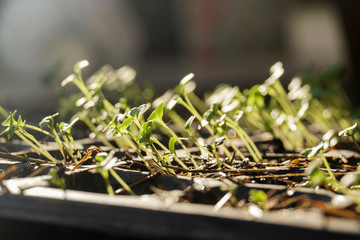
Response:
[0, 60, 360, 206]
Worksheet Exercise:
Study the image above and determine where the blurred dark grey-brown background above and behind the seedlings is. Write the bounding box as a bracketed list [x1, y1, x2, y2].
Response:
[0, 0, 360, 122]
